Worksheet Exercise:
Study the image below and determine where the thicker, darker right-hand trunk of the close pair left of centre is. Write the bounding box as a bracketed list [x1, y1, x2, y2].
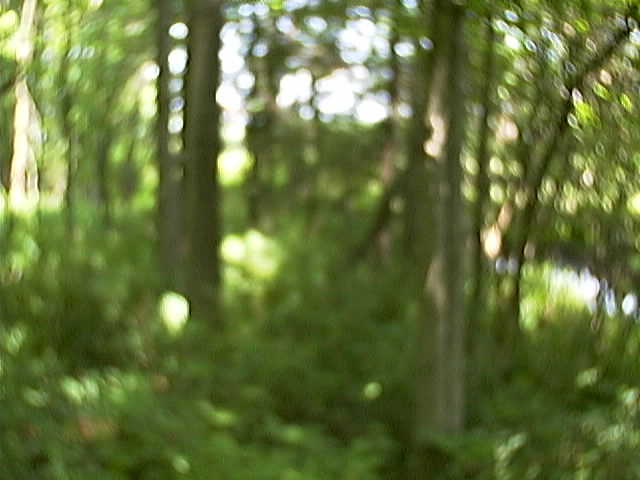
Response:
[184, 0, 223, 324]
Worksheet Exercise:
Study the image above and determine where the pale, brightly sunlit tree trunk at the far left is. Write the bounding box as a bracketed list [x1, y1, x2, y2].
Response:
[9, 0, 38, 209]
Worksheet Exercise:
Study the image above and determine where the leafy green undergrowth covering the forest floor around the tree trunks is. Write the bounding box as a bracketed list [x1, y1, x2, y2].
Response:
[0, 210, 640, 480]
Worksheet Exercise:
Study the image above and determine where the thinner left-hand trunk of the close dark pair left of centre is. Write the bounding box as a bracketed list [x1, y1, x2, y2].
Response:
[156, 0, 184, 290]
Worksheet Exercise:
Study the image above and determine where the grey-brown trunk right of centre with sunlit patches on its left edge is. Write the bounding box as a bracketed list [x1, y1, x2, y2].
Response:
[414, 0, 466, 472]
